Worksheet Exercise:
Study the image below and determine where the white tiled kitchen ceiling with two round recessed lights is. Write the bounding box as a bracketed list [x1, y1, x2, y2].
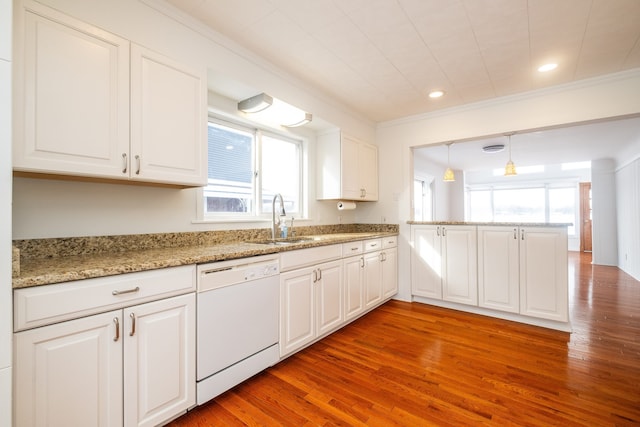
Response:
[168, 0, 640, 122]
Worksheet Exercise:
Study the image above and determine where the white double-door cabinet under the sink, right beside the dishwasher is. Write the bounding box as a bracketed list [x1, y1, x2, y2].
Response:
[280, 260, 344, 356]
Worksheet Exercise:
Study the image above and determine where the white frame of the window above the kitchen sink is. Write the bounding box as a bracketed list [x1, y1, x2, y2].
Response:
[194, 114, 309, 223]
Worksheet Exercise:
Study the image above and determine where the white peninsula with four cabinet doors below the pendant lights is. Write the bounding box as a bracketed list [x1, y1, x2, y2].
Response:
[408, 221, 571, 332]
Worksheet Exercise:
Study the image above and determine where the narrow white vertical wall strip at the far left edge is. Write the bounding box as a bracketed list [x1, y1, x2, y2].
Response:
[0, 0, 13, 426]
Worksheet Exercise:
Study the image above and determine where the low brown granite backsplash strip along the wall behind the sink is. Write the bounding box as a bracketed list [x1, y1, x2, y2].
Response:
[13, 224, 399, 260]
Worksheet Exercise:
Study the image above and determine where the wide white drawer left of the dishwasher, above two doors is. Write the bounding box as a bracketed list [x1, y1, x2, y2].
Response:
[13, 265, 196, 332]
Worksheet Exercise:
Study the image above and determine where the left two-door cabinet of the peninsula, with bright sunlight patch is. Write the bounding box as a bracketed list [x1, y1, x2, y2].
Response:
[411, 225, 478, 305]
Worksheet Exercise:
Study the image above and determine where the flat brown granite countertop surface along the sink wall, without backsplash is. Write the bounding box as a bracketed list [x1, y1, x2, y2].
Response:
[13, 229, 398, 289]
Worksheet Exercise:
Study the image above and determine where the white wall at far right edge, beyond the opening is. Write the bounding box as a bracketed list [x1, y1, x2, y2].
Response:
[616, 156, 640, 280]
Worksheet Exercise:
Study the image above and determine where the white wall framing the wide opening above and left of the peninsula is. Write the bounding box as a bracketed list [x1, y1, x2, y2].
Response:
[376, 70, 640, 299]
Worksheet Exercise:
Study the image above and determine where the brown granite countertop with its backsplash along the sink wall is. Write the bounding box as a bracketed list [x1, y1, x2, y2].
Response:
[13, 224, 398, 289]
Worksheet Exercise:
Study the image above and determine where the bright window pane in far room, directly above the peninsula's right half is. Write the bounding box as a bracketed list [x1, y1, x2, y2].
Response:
[493, 188, 545, 222]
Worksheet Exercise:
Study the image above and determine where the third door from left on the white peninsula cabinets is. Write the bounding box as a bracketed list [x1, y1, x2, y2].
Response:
[478, 226, 520, 313]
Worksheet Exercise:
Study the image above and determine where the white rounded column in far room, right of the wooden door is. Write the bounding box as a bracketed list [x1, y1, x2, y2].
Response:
[591, 159, 618, 266]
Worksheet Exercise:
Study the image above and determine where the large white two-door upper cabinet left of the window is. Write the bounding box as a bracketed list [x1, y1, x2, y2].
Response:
[13, 2, 207, 186]
